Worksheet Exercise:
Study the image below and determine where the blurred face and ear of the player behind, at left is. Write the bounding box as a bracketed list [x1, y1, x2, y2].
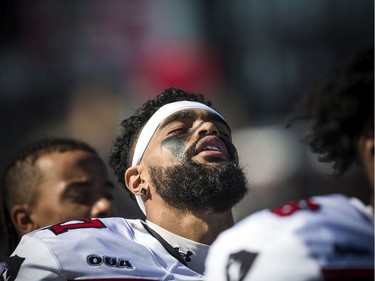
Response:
[10, 150, 114, 235]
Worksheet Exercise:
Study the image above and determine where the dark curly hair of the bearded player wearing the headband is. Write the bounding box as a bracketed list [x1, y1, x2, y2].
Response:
[109, 88, 217, 199]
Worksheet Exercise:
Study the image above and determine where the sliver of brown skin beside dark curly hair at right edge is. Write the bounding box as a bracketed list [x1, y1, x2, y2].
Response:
[358, 132, 374, 186]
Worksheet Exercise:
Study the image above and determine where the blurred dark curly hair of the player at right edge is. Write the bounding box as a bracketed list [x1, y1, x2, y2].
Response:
[287, 46, 374, 176]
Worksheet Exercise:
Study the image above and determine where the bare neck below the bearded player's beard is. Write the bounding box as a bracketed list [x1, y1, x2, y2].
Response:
[147, 203, 233, 245]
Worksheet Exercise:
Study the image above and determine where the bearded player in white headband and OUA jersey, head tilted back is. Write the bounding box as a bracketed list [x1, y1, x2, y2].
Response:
[2, 88, 247, 280]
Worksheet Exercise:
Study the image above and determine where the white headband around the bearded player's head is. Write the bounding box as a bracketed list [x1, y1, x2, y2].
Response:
[132, 101, 225, 215]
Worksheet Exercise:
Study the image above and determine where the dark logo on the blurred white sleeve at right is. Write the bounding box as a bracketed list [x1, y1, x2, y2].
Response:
[226, 251, 258, 281]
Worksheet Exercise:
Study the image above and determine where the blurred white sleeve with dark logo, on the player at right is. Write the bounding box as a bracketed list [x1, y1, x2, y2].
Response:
[205, 211, 322, 281]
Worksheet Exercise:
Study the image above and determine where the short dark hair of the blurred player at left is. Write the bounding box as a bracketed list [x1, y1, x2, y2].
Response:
[0, 137, 98, 254]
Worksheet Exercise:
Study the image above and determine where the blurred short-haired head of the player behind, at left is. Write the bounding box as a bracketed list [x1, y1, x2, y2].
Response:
[1, 138, 113, 253]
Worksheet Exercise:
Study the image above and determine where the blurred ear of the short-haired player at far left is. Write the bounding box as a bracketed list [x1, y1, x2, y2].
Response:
[10, 204, 37, 236]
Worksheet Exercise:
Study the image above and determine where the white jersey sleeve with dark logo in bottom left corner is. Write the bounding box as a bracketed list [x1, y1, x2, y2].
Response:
[2, 235, 66, 281]
